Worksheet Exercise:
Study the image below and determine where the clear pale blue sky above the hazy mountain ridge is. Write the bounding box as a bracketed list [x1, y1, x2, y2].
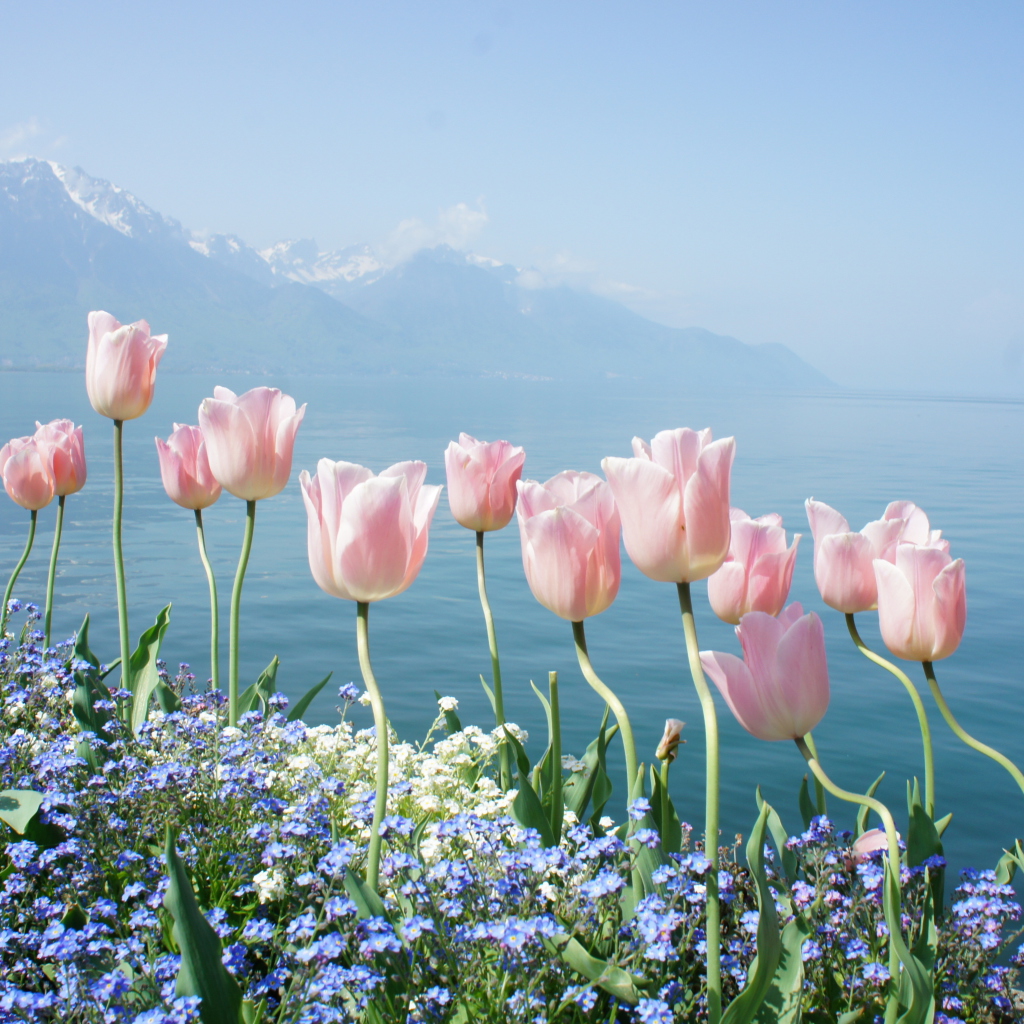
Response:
[0, 0, 1024, 391]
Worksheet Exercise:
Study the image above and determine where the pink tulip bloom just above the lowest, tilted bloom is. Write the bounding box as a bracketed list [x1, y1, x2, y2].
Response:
[708, 509, 800, 626]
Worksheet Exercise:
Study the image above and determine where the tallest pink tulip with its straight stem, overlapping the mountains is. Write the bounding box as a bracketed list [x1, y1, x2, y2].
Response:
[85, 309, 167, 690]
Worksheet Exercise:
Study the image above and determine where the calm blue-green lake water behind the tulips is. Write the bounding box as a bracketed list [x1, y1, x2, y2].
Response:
[0, 373, 1024, 867]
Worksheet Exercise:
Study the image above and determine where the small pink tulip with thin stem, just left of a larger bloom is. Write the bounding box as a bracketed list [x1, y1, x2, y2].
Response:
[155, 423, 221, 689]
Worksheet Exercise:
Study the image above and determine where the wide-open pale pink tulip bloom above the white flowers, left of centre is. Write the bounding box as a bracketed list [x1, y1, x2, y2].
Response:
[299, 459, 441, 601]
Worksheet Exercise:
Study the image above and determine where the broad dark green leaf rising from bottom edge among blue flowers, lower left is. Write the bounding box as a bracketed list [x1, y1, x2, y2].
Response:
[164, 825, 242, 1024]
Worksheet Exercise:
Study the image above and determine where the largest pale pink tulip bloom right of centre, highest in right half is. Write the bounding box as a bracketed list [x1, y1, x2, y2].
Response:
[601, 427, 736, 583]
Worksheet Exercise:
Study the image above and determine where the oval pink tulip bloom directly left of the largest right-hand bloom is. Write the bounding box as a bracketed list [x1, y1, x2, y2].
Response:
[516, 471, 622, 623]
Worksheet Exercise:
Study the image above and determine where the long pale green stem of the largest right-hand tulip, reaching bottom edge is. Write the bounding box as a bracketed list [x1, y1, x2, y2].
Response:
[677, 583, 722, 1024]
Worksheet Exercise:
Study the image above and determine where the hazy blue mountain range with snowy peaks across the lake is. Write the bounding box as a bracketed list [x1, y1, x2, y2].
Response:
[0, 159, 830, 388]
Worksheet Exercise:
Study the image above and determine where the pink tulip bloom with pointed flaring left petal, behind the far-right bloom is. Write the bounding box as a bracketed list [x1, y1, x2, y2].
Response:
[805, 498, 906, 614]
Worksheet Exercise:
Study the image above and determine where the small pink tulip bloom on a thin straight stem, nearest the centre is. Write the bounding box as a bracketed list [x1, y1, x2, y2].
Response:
[444, 434, 526, 532]
